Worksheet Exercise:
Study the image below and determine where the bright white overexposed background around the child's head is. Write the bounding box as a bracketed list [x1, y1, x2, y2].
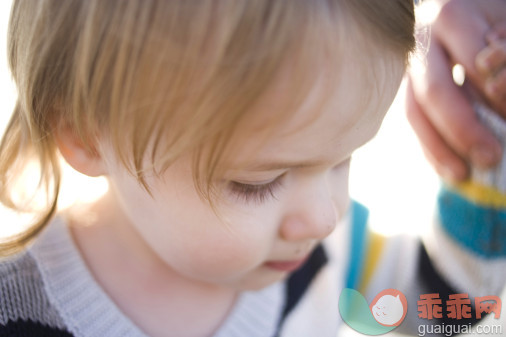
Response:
[0, 0, 438, 236]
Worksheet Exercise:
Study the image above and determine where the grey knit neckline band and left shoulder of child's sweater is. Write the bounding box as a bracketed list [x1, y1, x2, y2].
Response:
[0, 218, 285, 337]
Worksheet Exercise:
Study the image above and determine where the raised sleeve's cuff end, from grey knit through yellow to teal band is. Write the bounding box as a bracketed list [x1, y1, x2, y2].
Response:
[437, 104, 506, 259]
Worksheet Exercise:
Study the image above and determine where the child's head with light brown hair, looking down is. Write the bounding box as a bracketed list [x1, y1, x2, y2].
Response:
[0, 0, 414, 288]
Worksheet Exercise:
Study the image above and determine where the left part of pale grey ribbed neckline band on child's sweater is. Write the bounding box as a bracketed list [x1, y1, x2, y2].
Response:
[30, 218, 149, 337]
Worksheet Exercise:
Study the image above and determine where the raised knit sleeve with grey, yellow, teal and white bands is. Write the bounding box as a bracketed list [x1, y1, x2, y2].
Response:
[424, 104, 506, 320]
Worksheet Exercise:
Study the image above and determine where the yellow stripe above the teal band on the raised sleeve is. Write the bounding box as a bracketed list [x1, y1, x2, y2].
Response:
[455, 181, 506, 208]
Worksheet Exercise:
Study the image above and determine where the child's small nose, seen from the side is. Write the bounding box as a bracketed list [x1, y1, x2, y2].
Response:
[280, 175, 339, 241]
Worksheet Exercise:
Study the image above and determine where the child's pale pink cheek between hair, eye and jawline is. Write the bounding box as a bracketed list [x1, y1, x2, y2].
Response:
[110, 168, 277, 282]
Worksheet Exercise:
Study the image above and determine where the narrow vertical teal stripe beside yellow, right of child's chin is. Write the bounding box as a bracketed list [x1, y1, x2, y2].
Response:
[346, 201, 369, 289]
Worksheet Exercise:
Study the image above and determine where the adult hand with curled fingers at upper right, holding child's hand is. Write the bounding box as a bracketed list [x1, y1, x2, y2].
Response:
[407, 0, 506, 180]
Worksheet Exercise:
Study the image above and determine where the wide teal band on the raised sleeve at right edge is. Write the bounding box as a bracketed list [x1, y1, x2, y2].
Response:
[438, 187, 506, 259]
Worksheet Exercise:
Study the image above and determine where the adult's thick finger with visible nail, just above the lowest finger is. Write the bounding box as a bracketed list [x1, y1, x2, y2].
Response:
[413, 41, 501, 167]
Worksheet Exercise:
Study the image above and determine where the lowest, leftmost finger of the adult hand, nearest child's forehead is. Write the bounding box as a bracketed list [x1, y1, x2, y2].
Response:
[406, 81, 469, 182]
